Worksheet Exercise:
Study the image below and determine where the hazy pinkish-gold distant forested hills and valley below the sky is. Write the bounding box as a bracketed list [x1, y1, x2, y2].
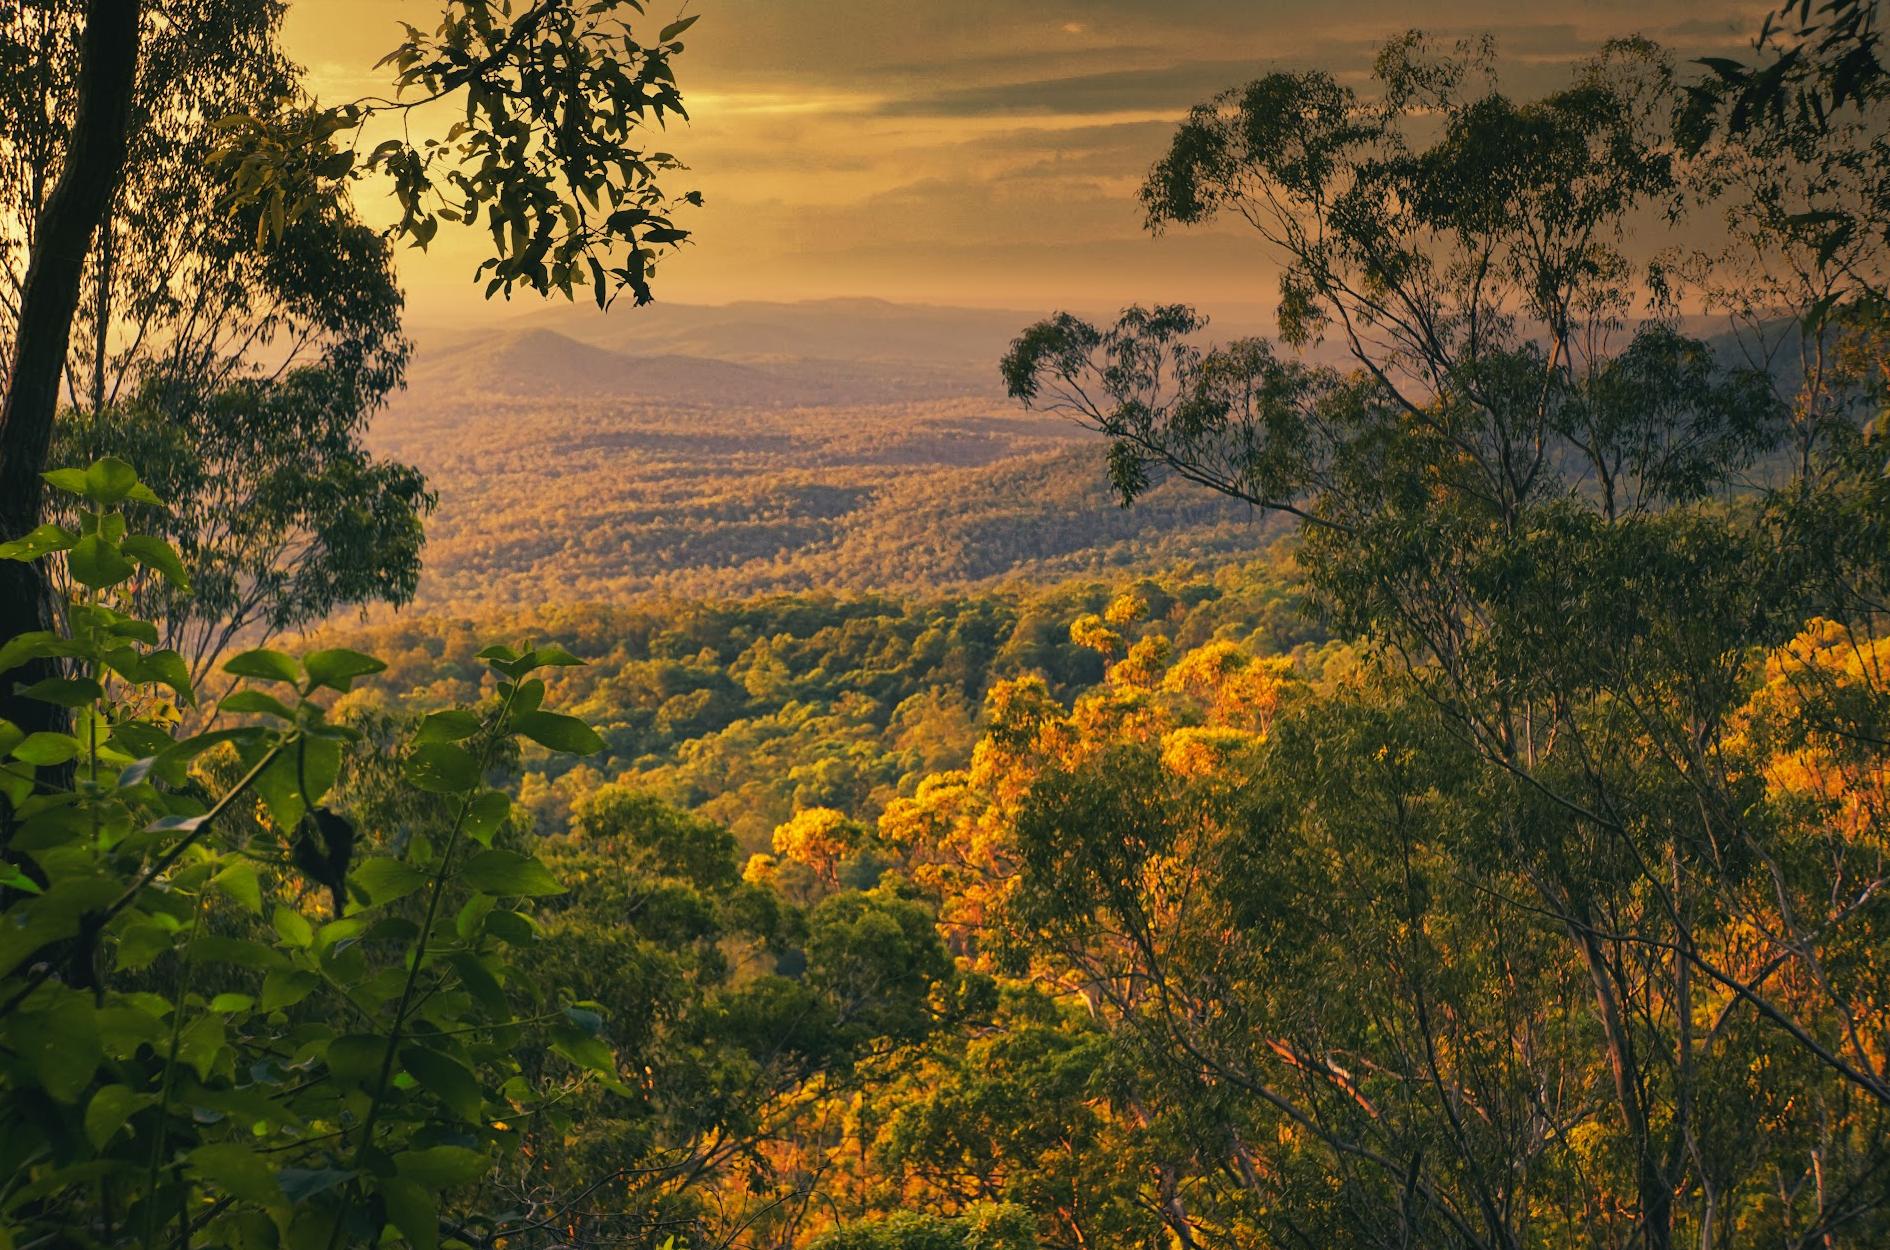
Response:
[372, 301, 1264, 607]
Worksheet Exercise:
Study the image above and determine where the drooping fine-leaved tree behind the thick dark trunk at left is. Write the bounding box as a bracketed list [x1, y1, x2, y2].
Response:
[0, 0, 431, 677]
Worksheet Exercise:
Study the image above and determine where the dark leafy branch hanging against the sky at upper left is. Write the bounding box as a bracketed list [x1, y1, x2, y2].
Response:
[212, 0, 701, 308]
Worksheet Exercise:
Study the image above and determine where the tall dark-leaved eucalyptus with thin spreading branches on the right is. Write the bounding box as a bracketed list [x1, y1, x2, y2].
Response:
[1004, 31, 1890, 1246]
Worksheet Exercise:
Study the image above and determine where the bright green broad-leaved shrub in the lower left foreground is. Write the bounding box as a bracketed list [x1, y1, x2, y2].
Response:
[0, 460, 622, 1246]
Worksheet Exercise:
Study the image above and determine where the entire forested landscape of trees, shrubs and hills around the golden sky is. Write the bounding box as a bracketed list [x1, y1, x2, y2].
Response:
[0, 0, 1890, 1250]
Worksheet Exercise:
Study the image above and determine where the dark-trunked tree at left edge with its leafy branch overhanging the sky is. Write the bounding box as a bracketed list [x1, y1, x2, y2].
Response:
[0, 0, 696, 724]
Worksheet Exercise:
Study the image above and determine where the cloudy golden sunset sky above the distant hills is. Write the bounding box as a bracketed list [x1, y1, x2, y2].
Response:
[285, 0, 1769, 325]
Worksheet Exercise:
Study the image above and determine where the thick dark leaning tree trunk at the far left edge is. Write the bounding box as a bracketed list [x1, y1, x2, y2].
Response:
[0, 0, 140, 732]
